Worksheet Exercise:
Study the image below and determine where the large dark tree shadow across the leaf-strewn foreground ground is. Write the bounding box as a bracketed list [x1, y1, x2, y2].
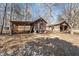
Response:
[0, 37, 79, 56]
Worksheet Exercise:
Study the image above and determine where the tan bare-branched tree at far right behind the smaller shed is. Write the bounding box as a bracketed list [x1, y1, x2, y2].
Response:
[58, 3, 79, 28]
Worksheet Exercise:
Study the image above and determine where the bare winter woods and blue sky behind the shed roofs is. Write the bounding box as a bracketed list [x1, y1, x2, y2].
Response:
[0, 3, 79, 34]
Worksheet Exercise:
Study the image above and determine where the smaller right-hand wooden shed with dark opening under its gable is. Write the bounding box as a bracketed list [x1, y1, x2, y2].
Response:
[49, 21, 71, 32]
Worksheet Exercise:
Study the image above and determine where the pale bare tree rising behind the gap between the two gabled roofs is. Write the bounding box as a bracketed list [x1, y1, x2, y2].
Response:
[44, 3, 58, 23]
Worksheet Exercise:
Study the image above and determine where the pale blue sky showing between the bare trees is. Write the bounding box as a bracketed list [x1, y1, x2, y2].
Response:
[0, 3, 65, 23]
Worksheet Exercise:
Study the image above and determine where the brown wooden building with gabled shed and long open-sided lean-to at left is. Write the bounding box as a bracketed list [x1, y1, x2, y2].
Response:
[10, 17, 47, 34]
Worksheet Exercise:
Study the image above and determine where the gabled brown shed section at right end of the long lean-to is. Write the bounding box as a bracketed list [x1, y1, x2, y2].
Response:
[31, 17, 47, 33]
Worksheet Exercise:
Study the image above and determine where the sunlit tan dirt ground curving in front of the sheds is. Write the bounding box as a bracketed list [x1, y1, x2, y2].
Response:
[0, 32, 79, 53]
